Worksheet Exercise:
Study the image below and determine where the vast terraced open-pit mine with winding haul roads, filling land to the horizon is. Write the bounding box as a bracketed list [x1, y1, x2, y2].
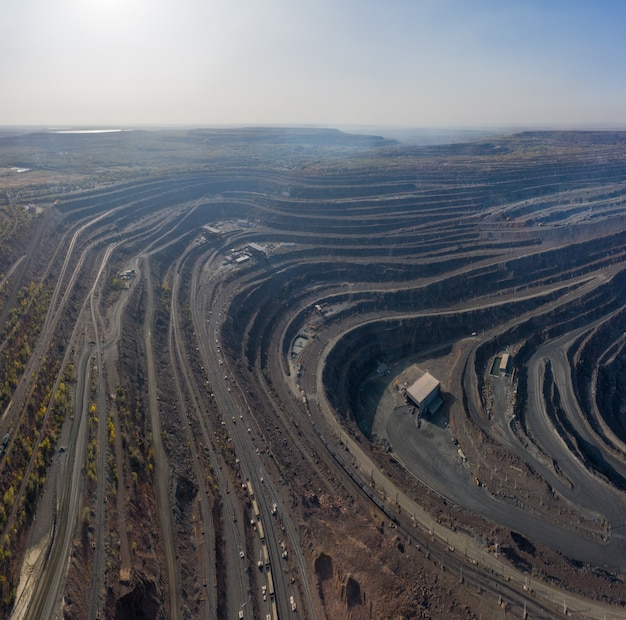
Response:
[0, 128, 626, 620]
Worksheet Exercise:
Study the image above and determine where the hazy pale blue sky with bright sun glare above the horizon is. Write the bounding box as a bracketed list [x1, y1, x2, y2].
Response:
[0, 0, 626, 127]
